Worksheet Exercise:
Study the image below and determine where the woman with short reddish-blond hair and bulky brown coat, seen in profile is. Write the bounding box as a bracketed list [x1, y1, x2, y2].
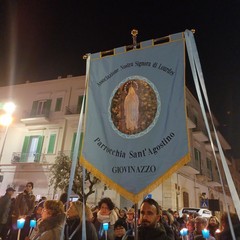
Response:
[26, 200, 65, 240]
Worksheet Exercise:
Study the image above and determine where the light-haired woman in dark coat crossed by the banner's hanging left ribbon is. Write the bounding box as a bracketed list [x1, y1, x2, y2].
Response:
[65, 201, 98, 240]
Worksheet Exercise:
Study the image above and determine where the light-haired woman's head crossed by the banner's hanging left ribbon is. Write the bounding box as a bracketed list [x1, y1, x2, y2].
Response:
[66, 201, 93, 222]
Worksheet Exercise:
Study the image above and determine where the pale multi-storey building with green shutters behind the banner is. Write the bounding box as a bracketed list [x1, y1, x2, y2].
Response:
[0, 76, 240, 212]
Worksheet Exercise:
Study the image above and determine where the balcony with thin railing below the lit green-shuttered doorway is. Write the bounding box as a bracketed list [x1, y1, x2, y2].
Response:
[11, 152, 47, 164]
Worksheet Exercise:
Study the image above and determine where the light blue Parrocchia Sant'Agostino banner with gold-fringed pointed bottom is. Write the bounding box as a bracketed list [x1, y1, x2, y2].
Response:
[81, 33, 189, 203]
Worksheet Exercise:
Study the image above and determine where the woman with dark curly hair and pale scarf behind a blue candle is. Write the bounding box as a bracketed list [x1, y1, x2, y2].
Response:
[94, 198, 118, 240]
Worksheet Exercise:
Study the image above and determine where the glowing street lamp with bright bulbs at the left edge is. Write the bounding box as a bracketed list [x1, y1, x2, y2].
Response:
[0, 102, 16, 162]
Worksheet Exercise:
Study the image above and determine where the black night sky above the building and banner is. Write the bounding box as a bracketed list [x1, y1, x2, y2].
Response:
[0, 0, 240, 158]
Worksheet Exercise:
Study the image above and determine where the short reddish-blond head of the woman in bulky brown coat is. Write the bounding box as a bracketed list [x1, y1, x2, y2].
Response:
[42, 200, 64, 220]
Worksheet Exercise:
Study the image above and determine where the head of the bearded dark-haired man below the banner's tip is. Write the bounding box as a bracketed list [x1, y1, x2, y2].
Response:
[140, 198, 160, 228]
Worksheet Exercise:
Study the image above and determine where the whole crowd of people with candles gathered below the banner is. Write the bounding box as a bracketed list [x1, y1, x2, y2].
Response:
[0, 182, 240, 240]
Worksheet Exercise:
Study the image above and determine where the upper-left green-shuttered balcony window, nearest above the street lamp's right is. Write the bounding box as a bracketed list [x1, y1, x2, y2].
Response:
[31, 99, 52, 117]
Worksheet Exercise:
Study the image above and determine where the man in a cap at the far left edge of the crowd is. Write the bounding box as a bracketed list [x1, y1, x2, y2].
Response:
[0, 187, 15, 239]
